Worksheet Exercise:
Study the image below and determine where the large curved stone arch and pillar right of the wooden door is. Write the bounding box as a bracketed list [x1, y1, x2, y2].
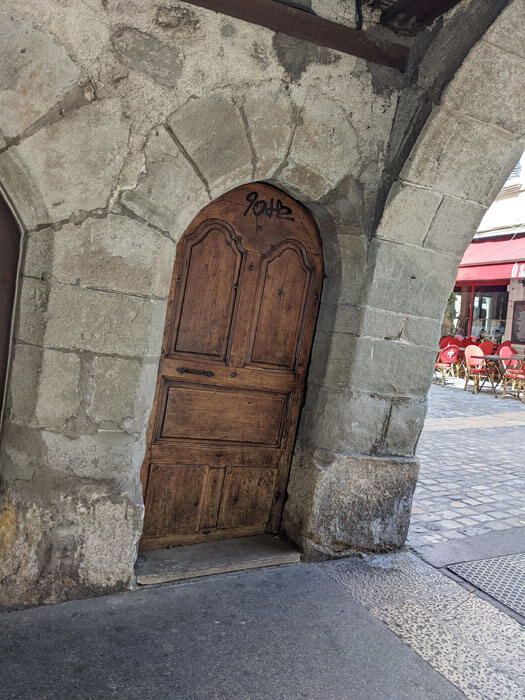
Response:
[285, 0, 525, 557]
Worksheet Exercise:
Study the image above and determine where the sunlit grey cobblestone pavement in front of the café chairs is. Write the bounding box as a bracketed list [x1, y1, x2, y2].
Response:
[408, 382, 525, 547]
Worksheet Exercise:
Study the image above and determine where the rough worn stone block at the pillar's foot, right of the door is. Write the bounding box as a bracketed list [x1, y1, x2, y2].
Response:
[283, 448, 419, 561]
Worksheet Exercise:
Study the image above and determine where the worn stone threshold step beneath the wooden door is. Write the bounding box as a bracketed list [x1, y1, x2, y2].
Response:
[135, 535, 301, 586]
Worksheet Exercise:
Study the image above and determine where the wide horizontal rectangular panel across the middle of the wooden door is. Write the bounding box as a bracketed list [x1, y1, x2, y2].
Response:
[159, 384, 287, 446]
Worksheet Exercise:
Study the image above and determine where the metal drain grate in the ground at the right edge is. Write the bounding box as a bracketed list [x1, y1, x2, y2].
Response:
[448, 554, 525, 616]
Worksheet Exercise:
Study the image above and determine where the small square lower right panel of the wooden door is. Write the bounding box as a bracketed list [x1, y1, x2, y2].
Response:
[218, 467, 277, 532]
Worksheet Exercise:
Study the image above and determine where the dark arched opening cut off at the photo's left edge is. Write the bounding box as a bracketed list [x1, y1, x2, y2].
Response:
[0, 196, 20, 416]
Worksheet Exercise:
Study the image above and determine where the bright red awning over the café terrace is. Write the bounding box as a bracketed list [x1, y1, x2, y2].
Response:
[456, 236, 525, 284]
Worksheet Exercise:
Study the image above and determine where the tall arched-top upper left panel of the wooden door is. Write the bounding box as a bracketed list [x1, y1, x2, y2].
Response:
[173, 226, 242, 360]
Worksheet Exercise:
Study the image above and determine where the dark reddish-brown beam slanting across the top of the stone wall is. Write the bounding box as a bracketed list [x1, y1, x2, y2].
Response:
[184, 0, 409, 73]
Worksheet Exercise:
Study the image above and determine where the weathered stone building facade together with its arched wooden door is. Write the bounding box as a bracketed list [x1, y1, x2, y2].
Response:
[0, 0, 525, 606]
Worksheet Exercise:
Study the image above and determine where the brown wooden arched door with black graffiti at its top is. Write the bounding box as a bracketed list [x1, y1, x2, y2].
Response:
[141, 184, 323, 549]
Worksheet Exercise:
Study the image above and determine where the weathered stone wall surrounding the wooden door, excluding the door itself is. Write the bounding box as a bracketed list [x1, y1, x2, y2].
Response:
[0, 0, 525, 606]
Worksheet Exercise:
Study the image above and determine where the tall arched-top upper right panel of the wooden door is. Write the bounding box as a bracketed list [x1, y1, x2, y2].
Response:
[251, 245, 312, 369]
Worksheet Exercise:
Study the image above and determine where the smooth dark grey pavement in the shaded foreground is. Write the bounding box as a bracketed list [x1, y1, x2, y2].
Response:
[0, 564, 463, 700]
